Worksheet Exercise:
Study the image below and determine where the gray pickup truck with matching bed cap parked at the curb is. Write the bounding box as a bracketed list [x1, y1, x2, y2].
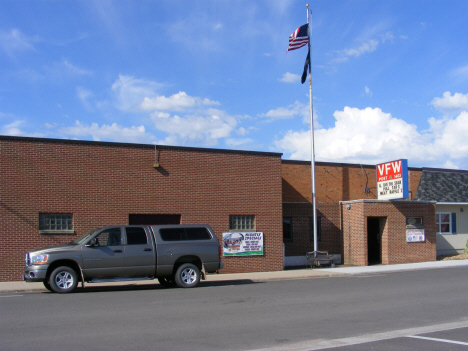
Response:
[23, 225, 224, 293]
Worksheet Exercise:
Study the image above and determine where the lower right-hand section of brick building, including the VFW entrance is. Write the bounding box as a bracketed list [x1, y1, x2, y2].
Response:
[281, 160, 436, 266]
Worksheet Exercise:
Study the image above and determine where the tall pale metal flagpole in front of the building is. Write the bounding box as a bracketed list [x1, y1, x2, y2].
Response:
[306, 4, 318, 251]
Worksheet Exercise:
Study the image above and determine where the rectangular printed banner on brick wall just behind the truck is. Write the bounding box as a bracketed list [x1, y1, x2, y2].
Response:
[223, 232, 263, 256]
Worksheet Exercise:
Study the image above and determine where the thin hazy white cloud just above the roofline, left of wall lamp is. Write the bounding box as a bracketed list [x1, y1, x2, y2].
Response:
[58, 121, 154, 143]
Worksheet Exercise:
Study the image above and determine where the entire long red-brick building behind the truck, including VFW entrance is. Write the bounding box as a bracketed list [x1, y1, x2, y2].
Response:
[0, 136, 468, 281]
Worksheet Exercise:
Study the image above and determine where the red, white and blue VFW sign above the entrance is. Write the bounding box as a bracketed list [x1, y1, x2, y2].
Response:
[376, 160, 408, 200]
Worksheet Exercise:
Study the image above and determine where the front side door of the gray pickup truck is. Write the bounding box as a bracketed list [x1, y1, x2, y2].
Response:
[82, 227, 125, 279]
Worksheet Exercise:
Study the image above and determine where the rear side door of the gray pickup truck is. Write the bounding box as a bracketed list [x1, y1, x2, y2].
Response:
[125, 227, 156, 278]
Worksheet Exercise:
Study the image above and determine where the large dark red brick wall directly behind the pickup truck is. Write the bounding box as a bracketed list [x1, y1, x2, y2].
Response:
[0, 137, 283, 281]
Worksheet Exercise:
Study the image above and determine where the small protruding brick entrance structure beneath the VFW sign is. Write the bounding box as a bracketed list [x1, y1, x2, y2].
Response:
[342, 200, 437, 266]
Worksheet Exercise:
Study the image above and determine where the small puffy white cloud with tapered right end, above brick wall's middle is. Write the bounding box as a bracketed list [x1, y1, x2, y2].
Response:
[140, 91, 219, 111]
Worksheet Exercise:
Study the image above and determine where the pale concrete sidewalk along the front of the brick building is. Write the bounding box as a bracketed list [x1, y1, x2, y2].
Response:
[0, 260, 468, 293]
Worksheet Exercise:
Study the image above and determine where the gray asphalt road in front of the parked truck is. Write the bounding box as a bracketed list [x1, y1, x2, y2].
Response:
[0, 267, 468, 350]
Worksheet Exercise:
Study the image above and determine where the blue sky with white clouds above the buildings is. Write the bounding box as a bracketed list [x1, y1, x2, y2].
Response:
[0, 0, 468, 169]
